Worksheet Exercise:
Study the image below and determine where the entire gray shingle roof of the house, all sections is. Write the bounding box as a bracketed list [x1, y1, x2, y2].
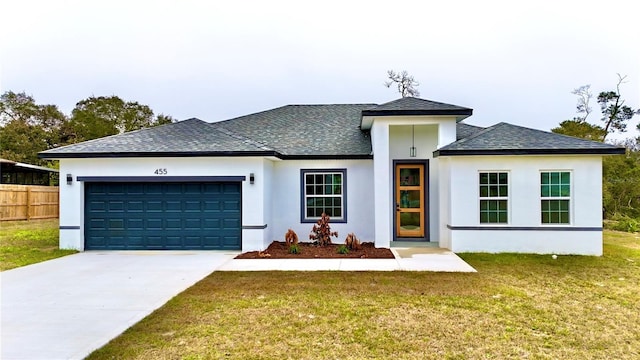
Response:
[40, 98, 624, 159]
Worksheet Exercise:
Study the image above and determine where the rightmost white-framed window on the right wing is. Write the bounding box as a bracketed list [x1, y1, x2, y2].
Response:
[540, 171, 571, 224]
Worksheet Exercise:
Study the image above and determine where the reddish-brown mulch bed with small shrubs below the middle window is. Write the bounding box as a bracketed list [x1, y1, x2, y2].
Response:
[235, 241, 395, 259]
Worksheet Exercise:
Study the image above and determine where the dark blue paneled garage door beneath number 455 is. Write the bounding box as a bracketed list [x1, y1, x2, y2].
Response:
[85, 182, 242, 250]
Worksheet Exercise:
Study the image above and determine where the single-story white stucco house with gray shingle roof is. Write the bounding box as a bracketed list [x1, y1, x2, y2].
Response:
[40, 97, 624, 255]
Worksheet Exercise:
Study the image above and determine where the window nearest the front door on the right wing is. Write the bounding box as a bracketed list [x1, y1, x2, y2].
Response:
[479, 172, 509, 224]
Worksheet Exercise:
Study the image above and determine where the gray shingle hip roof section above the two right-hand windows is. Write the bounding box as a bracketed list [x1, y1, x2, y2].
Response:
[434, 123, 624, 156]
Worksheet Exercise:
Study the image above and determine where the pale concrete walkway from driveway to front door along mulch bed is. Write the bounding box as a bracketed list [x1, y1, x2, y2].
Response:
[217, 248, 476, 272]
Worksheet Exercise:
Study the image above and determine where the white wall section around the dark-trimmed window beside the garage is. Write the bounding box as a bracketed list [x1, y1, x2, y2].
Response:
[269, 160, 376, 247]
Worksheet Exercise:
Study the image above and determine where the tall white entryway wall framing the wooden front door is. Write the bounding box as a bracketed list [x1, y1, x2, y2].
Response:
[371, 116, 456, 247]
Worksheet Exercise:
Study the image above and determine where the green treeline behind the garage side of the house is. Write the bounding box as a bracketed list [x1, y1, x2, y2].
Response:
[0, 91, 174, 167]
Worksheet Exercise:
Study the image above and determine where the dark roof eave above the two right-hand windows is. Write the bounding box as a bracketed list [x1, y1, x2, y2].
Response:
[433, 148, 625, 157]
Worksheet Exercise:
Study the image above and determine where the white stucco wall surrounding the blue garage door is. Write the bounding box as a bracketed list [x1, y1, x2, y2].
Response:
[60, 157, 272, 251]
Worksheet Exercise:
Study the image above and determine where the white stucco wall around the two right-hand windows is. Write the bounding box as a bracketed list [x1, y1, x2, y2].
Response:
[441, 156, 602, 255]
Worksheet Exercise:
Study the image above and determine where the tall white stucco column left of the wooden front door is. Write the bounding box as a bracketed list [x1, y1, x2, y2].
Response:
[371, 123, 393, 247]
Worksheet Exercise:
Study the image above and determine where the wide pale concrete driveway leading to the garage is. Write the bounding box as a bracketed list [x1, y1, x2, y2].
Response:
[0, 251, 237, 360]
